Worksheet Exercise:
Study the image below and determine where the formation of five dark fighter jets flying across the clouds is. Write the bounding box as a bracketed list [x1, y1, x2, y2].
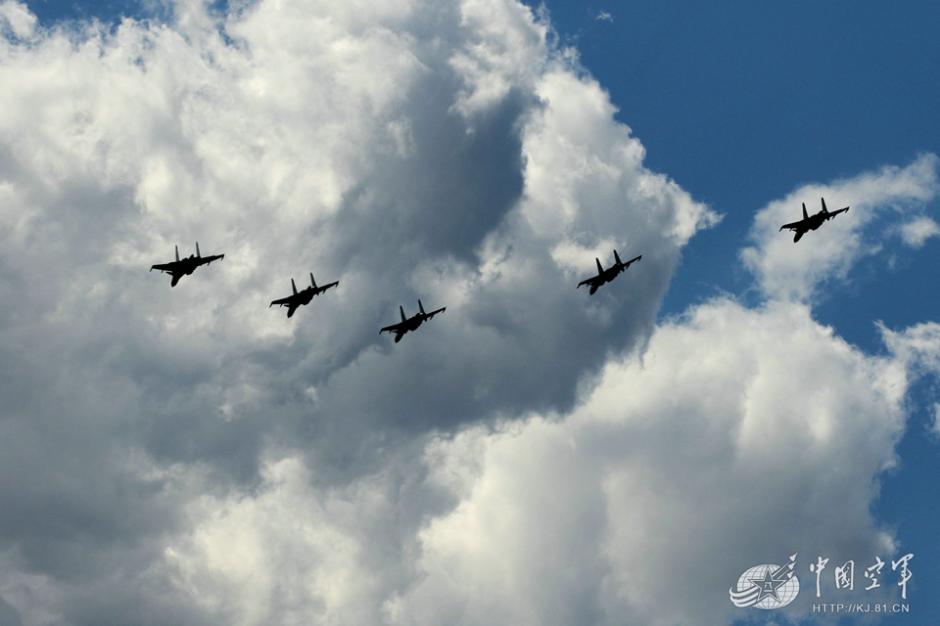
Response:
[150, 198, 849, 343]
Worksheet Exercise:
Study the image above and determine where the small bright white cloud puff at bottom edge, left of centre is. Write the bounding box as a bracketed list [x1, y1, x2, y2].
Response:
[165, 458, 402, 624]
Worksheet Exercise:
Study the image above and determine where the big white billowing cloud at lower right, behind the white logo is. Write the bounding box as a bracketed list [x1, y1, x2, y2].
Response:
[398, 301, 906, 624]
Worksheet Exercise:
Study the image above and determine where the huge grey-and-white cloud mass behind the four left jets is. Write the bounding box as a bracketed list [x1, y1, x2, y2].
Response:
[0, 0, 717, 624]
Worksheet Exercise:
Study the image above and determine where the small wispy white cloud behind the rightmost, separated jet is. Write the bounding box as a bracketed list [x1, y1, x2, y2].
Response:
[741, 154, 940, 301]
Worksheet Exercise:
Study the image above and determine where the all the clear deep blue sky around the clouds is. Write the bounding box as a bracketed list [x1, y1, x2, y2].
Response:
[12, 0, 940, 623]
